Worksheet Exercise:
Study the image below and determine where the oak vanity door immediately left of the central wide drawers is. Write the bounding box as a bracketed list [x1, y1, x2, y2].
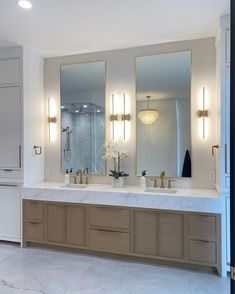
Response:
[66, 206, 86, 246]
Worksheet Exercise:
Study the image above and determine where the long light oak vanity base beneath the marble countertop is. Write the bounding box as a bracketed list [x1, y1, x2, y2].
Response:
[23, 200, 221, 272]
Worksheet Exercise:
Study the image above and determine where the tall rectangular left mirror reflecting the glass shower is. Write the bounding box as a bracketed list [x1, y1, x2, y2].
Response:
[61, 62, 105, 174]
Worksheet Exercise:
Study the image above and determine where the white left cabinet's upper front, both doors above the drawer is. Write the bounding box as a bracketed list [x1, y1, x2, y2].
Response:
[0, 57, 22, 169]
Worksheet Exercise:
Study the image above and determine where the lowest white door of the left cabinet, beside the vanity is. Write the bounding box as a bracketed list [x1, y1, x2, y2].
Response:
[0, 184, 21, 242]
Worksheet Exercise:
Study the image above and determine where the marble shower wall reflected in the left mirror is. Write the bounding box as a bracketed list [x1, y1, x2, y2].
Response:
[61, 111, 105, 173]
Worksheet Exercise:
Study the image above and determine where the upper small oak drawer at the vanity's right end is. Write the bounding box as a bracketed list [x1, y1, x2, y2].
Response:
[188, 215, 216, 238]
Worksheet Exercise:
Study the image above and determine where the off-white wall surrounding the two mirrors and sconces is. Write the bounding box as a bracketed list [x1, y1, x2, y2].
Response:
[44, 38, 217, 188]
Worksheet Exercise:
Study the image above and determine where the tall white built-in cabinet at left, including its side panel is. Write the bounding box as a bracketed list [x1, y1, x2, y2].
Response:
[0, 47, 44, 242]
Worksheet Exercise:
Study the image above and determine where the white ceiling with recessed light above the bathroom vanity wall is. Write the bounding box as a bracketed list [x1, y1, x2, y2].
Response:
[0, 0, 230, 57]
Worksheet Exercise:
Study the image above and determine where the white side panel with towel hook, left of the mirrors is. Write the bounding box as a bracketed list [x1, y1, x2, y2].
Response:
[23, 49, 45, 183]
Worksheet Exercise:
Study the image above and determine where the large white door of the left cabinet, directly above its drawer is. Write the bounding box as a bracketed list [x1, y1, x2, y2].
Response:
[0, 86, 21, 168]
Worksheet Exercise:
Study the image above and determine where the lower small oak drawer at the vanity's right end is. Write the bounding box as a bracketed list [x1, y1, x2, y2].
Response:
[188, 240, 216, 264]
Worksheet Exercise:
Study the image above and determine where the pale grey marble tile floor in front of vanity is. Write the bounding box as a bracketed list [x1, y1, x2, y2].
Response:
[0, 242, 229, 294]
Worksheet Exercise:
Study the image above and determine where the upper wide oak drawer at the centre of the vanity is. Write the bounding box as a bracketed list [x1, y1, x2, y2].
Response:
[90, 207, 130, 229]
